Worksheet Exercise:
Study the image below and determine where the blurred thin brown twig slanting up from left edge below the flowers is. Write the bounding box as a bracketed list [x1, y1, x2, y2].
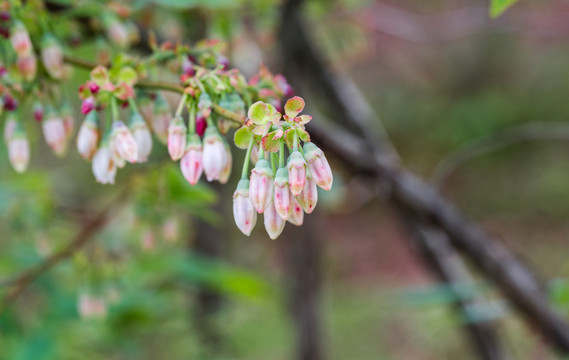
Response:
[0, 187, 129, 313]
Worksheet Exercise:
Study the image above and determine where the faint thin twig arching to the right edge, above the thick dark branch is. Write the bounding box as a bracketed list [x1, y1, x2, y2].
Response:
[431, 122, 569, 189]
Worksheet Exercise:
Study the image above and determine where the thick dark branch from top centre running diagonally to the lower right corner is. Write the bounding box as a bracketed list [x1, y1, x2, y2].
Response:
[280, 2, 569, 353]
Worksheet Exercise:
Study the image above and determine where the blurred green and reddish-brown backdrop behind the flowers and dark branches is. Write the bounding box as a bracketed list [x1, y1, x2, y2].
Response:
[0, 0, 569, 360]
